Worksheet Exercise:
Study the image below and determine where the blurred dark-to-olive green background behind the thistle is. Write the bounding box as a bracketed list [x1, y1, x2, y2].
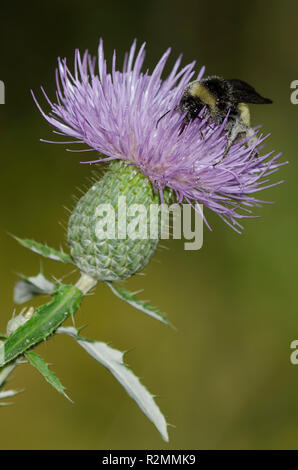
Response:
[0, 0, 298, 449]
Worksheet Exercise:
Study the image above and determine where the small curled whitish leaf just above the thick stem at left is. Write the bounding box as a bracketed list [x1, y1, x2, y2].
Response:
[13, 273, 56, 304]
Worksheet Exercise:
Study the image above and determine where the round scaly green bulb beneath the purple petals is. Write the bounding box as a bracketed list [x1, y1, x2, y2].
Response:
[68, 161, 170, 281]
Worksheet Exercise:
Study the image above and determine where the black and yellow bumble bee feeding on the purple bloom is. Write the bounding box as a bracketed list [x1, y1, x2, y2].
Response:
[177, 76, 272, 154]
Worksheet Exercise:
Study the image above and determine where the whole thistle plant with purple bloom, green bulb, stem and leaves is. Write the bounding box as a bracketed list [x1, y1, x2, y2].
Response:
[0, 41, 281, 441]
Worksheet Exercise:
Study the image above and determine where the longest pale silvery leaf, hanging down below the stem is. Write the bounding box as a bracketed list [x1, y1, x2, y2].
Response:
[57, 327, 169, 442]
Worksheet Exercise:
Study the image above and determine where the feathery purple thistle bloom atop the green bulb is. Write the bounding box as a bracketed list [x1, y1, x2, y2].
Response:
[33, 40, 282, 231]
